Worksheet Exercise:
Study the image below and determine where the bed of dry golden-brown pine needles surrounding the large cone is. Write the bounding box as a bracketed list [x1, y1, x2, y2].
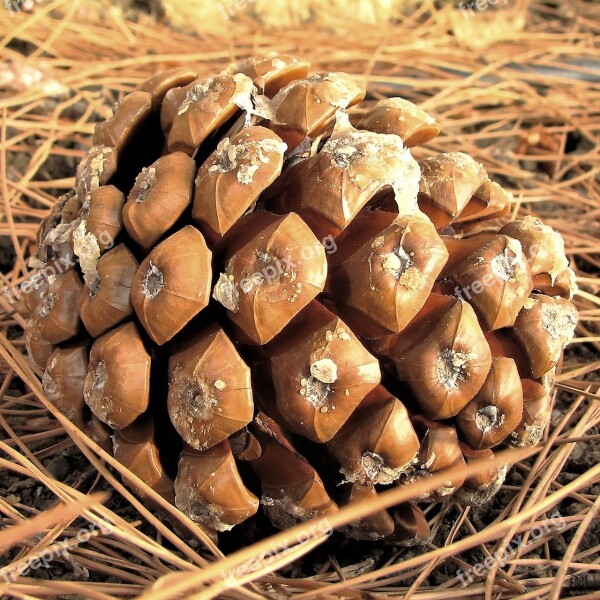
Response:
[0, 0, 600, 600]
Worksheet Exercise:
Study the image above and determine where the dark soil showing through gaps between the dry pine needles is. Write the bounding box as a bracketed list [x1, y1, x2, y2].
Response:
[0, 1, 600, 597]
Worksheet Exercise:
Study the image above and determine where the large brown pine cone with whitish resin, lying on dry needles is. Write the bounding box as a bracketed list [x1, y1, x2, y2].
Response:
[26, 55, 577, 543]
